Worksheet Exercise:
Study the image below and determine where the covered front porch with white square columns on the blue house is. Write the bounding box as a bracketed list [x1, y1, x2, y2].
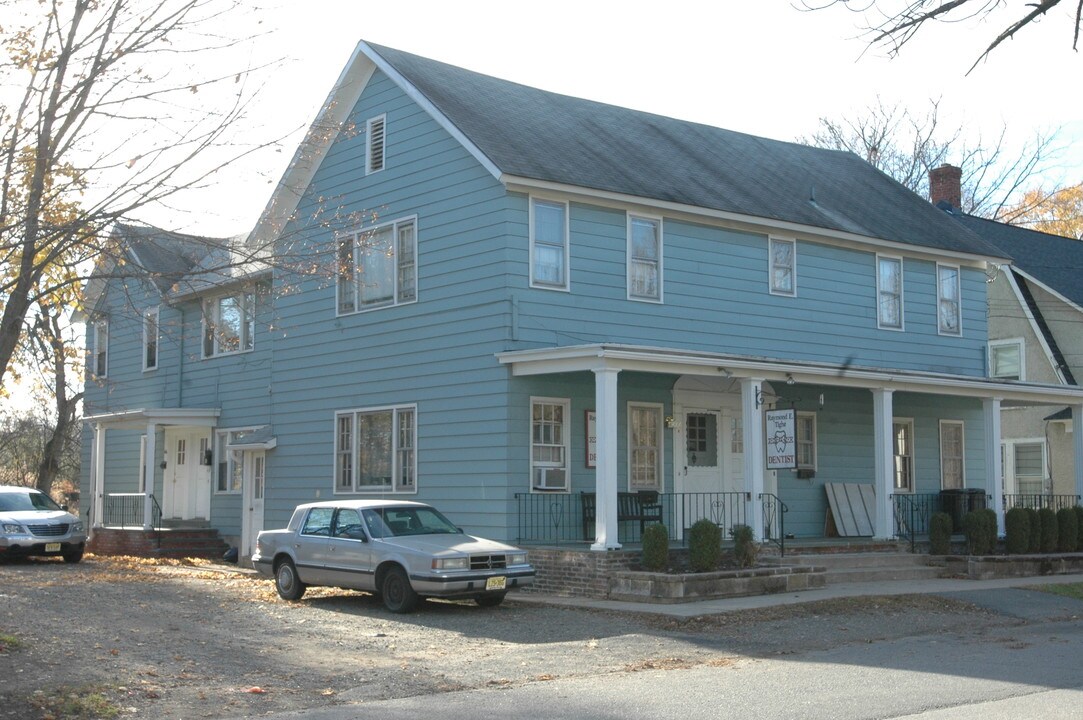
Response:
[498, 345, 1083, 551]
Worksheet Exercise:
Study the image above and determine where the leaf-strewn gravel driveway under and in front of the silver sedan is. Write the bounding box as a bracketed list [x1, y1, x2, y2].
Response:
[0, 557, 1019, 720]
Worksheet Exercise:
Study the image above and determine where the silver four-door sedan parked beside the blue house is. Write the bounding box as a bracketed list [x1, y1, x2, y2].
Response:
[252, 500, 534, 613]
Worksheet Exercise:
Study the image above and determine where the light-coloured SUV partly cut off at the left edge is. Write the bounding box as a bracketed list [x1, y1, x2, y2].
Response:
[0, 485, 87, 563]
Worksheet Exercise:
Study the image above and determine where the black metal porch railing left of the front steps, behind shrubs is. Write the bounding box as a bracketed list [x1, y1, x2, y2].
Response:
[516, 493, 753, 545]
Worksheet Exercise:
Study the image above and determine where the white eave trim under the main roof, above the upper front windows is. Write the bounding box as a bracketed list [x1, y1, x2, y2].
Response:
[499, 174, 1006, 272]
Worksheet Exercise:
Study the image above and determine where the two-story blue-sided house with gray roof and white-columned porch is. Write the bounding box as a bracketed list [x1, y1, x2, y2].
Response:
[83, 42, 1083, 555]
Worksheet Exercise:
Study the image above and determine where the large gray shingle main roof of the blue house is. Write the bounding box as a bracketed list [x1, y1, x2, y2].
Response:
[368, 43, 1002, 258]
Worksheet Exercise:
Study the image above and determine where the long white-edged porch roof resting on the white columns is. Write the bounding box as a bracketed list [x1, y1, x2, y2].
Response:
[496, 344, 1083, 407]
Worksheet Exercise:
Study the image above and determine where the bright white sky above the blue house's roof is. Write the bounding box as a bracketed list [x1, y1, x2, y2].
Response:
[131, 0, 1083, 235]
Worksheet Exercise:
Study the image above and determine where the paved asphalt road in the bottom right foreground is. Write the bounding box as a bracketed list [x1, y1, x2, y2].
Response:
[228, 589, 1083, 720]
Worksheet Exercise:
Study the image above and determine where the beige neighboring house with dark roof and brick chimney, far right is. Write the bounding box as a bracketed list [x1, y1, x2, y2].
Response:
[929, 166, 1083, 507]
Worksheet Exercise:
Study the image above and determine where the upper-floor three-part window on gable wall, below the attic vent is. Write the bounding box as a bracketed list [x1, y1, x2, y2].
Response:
[338, 218, 417, 313]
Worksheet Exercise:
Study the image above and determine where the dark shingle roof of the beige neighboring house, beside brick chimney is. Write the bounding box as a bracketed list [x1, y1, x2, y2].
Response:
[955, 214, 1083, 307]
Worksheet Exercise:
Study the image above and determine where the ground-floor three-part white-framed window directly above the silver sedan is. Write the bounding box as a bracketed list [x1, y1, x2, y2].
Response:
[335, 405, 417, 493]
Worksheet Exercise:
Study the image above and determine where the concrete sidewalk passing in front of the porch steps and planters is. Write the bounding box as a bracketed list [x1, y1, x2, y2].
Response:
[507, 574, 1083, 617]
